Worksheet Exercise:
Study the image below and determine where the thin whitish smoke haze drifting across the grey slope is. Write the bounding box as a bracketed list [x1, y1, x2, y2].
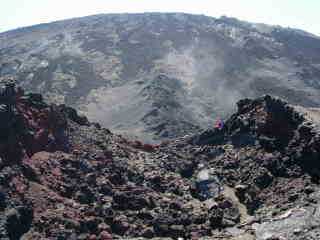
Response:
[155, 40, 243, 125]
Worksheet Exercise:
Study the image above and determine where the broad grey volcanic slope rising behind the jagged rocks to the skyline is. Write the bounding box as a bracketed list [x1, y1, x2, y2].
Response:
[0, 13, 320, 141]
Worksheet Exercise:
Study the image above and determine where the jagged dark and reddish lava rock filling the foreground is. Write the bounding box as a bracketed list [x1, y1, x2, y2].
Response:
[0, 87, 320, 240]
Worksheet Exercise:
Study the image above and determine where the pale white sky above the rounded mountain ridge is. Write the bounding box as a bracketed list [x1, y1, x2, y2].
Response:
[0, 0, 320, 36]
